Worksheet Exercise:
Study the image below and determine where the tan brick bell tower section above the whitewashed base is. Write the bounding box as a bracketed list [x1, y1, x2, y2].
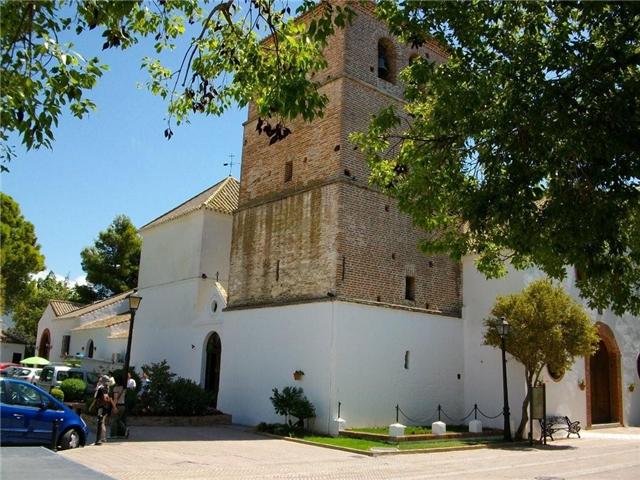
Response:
[228, 3, 461, 317]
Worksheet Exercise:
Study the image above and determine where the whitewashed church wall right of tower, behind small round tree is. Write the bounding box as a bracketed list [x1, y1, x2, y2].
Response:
[463, 256, 640, 427]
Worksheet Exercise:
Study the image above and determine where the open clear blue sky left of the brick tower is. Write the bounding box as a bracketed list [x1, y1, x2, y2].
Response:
[2, 27, 246, 280]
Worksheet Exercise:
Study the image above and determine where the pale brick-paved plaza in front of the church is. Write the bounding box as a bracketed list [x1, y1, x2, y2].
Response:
[60, 426, 640, 480]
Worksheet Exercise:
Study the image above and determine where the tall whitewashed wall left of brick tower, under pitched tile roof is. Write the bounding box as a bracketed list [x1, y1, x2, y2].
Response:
[131, 210, 232, 384]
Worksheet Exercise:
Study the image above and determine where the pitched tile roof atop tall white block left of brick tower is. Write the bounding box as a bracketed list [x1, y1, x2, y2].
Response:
[140, 177, 240, 230]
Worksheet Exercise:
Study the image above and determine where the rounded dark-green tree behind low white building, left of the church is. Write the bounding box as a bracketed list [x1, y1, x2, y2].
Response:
[78, 215, 142, 301]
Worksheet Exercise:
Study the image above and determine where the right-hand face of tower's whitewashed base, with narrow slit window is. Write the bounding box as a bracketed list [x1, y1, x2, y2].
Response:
[332, 302, 464, 427]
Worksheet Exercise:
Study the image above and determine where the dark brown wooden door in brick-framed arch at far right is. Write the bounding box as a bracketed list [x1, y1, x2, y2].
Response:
[585, 322, 622, 426]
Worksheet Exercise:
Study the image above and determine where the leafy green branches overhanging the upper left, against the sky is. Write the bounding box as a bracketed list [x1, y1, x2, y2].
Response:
[0, 0, 350, 170]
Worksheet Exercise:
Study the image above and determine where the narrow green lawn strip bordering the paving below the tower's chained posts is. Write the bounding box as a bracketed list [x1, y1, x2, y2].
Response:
[302, 435, 502, 452]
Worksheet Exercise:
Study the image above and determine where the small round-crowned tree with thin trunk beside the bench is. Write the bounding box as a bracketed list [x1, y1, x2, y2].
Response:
[484, 279, 599, 438]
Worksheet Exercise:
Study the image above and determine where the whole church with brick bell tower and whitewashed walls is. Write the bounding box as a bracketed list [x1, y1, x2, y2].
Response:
[37, 3, 640, 432]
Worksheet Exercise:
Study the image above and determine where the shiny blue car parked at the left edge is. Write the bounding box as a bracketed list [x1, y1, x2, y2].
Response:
[0, 378, 89, 450]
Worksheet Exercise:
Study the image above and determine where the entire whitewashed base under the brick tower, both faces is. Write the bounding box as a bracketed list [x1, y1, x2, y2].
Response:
[219, 302, 463, 431]
